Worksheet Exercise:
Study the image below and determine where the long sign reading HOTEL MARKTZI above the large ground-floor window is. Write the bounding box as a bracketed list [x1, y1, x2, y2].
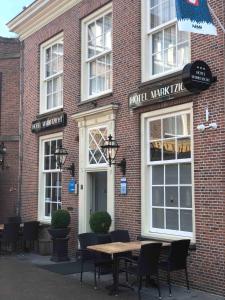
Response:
[128, 76, 190, 108]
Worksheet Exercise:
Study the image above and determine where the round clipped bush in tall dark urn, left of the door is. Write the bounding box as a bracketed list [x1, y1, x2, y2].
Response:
[48, 209, 70, 262]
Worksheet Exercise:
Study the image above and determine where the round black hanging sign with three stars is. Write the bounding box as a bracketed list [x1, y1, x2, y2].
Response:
[182, 60, 214, 92]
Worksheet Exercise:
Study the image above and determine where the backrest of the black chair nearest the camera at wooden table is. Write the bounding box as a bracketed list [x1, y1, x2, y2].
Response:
[138, 243, 162, 275]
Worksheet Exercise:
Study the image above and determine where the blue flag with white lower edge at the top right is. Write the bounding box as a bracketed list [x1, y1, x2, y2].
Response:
[176, 0, 217, 35]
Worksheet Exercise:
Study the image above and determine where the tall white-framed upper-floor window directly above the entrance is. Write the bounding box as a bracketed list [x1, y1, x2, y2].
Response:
[82, 5, 112, 100]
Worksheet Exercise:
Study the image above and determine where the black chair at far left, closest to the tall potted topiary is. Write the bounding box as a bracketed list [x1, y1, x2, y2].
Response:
[22, 221, 39, 250]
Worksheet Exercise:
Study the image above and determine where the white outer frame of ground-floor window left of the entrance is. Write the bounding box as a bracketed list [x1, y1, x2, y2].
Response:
[38, 132, 63, 224]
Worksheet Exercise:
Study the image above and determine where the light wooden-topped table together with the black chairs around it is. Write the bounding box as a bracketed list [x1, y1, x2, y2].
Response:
[77, 230, 190, 299]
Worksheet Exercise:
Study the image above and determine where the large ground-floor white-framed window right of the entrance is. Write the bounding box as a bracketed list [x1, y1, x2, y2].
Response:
[144, 104, 193, 237]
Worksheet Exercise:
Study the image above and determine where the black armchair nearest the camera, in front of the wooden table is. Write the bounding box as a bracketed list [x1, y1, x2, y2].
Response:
[119, 243, 162, 299]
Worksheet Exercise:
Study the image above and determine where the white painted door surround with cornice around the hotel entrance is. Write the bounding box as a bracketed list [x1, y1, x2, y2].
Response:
[72, 104, 118, 233]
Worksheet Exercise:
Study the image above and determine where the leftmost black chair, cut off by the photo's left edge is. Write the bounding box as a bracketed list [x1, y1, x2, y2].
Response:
[0, 223, 20, 253]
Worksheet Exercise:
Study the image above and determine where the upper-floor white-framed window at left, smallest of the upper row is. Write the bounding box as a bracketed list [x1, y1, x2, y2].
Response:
[40, 35, 63, 113]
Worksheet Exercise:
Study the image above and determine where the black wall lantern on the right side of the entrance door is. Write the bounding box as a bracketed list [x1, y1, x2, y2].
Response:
[101, 134, 127, 176]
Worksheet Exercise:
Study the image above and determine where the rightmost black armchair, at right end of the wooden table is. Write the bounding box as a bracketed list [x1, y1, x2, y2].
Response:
[159, 240, 190, 296]
